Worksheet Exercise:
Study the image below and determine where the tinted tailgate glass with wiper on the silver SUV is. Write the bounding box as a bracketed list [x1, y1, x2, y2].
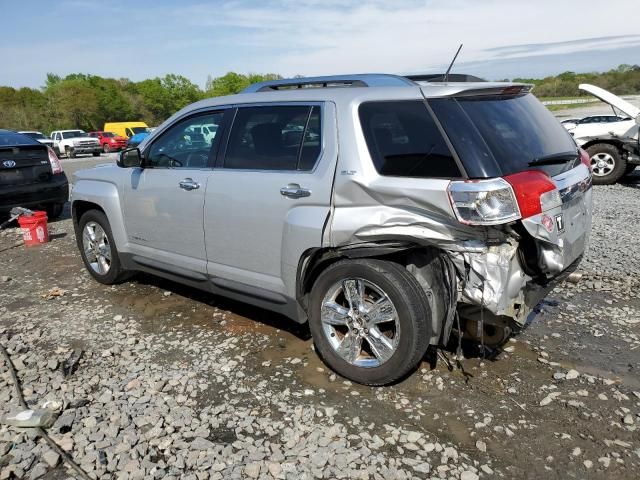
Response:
[428, 94, 579, 178]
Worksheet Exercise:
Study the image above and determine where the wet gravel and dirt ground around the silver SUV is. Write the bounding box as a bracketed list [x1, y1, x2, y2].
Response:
[0, 173, 640, 480]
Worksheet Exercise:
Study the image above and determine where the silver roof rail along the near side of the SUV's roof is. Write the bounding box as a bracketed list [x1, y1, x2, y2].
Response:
[241, 73, 416, 93]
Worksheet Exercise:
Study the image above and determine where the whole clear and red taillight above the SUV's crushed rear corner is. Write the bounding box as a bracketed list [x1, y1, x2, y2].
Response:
[448, 170, 562, 225]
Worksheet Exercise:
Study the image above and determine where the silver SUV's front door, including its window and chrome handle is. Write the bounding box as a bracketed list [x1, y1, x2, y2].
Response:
[123, 110, 224, 278]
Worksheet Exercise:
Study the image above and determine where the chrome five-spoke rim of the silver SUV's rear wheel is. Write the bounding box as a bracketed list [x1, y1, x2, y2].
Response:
[320, 278, 400, 368]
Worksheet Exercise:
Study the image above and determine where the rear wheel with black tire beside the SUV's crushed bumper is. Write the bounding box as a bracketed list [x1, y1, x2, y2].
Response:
[309, 259, 432, 385]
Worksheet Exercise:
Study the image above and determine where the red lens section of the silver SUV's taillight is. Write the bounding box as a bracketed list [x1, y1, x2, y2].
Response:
[504, 170, 562, 218]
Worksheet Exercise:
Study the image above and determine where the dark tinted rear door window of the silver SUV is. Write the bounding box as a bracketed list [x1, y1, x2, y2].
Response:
[224, 105, 321, 171]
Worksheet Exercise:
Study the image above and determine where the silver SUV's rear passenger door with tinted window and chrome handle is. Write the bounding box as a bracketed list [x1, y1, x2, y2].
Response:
[204, 103, 337, 299]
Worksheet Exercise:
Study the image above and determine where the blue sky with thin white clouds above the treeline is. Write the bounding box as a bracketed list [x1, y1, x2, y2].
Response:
[0, 0, 640, 87]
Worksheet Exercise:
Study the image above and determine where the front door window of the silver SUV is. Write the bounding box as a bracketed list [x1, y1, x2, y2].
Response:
[145, 112, 224, 168]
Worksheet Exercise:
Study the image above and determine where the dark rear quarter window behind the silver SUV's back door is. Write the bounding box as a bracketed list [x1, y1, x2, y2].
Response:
[359, 100, 461, 178]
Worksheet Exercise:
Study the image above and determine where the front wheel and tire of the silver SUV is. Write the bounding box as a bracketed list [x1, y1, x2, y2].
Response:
[76, 210, 127, 285]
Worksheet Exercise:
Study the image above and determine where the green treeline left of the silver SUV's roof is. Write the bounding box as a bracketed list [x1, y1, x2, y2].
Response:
[0, 72, 281, 134]
